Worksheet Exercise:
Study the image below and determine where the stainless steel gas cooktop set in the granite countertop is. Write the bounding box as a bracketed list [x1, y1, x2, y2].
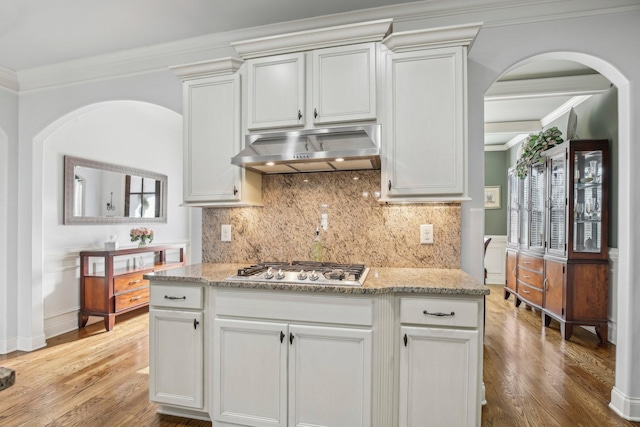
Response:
[226, 261, 369, 286]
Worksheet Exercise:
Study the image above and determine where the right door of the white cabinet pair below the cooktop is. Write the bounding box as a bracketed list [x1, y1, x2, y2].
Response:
[289, 325, 372, 427]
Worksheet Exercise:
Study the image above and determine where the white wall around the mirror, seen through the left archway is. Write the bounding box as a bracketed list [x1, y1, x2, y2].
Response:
[42, 101, 189, 338]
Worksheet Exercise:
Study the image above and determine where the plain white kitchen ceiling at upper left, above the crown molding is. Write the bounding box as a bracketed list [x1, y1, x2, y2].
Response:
[0, 0, 412, 71]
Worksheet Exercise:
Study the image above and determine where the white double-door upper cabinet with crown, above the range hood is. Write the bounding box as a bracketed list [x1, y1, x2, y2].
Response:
[232, 19, 392, 131]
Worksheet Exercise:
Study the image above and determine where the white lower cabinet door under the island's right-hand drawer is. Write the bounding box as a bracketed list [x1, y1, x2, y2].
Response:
[399, 327, 479, 427]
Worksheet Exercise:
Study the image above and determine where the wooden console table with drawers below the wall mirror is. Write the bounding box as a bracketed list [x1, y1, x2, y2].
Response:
[78, 245, 185, 331]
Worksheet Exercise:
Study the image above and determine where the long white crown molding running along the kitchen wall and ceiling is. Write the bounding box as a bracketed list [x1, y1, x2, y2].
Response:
[6, 0, 640, 92]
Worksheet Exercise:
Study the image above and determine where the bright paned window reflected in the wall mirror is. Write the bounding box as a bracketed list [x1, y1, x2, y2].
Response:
[125, 175, 161, 218]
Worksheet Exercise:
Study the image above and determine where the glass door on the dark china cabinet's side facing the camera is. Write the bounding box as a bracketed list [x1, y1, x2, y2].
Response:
[573, 151, 603, 253]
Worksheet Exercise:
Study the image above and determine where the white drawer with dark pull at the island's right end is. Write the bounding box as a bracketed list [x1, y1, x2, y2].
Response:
[400, 297, 478, 328]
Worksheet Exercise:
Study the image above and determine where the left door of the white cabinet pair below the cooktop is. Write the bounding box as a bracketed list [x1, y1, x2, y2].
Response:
[212, 319, 289, 427]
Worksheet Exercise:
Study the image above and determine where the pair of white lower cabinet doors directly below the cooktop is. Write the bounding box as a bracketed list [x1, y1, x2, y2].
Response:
[213, 319, 371, 427]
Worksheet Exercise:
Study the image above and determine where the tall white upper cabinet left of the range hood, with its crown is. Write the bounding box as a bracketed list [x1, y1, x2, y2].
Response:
[173, 58, 261, 206]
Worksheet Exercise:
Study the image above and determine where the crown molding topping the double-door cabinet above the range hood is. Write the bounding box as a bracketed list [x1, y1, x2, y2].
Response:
[231, 19, 393, 59]
